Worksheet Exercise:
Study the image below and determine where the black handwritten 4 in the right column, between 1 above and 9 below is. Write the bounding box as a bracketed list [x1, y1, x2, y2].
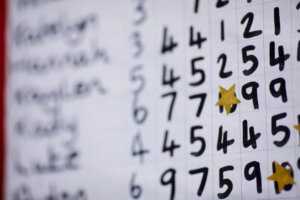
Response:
[269, 41, 290, 71]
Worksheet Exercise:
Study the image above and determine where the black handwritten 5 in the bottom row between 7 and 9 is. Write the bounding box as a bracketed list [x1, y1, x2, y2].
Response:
[218, 165, 234, 199]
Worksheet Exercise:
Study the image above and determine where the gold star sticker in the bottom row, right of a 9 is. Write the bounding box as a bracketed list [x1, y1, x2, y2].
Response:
[268, 161, 296, 193]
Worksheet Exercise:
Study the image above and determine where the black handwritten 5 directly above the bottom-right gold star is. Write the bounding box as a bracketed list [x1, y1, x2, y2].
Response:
[271, 112, 290, 147]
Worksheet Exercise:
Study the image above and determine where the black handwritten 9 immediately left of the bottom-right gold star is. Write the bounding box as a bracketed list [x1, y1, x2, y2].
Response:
[244, 161, 262, 193]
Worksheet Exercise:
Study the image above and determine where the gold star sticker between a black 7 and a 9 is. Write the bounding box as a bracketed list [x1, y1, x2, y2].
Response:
[216, 84, 241, 115]
